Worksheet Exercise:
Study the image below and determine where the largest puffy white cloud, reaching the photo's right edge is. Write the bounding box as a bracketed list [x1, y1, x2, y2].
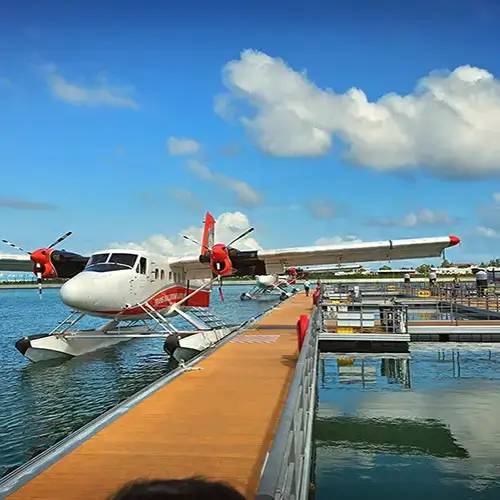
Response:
[219, 50, 500, 177]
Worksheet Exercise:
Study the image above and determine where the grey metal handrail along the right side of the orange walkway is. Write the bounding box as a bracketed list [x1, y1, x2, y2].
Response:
[255, 307, 322, 500]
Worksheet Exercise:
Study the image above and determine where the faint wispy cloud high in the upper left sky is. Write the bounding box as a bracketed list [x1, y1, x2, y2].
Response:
[41, 64, 139, 109]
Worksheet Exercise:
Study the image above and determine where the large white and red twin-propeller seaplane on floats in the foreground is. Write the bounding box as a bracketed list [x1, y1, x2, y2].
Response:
[0, 212, 460, 362]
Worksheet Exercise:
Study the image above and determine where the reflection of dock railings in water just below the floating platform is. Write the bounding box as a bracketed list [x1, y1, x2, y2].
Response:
[320, 353, 411, 389]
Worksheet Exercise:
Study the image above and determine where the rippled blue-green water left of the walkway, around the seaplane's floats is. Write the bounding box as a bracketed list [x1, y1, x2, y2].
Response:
[0, 286, 273, 477]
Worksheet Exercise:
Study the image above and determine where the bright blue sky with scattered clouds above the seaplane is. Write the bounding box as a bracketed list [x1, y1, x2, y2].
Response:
[0, 0, 500, 261]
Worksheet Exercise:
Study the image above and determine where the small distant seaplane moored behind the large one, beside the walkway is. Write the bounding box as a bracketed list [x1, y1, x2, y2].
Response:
[240, 264, 363, 300]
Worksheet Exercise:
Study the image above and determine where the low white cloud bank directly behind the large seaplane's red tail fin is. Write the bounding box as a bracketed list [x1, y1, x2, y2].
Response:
[109, 212, 262, 257]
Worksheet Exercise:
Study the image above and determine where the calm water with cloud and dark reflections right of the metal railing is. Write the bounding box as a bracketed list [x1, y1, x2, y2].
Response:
[315, 344, 500, 500]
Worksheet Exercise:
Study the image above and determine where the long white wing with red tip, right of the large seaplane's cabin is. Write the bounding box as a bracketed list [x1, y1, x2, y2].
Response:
[170, 236, 460, 279]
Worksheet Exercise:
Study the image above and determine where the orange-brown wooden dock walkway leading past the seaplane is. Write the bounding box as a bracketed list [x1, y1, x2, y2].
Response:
[8, 293, 312, 500]
